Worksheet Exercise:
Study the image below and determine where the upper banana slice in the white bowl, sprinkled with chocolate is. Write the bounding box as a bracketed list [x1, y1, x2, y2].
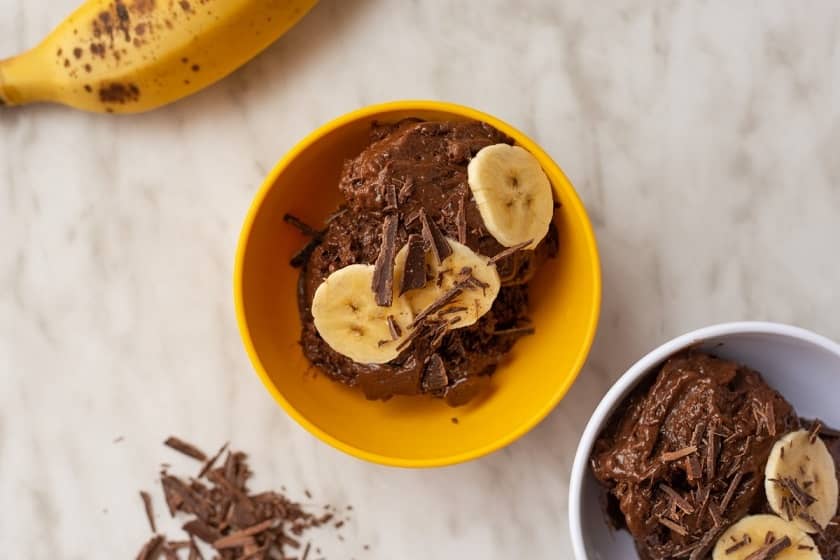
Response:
[764, 430, 838, 533]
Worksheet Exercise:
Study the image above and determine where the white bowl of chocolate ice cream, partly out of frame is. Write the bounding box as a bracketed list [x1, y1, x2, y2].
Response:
[569, 322, 840, 560]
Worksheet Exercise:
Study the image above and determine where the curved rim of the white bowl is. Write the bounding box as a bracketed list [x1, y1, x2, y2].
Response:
[568, 321, 840, 560]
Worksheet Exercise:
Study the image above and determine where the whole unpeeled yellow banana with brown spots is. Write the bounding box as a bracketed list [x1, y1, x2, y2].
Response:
[0, 0, 317, 113]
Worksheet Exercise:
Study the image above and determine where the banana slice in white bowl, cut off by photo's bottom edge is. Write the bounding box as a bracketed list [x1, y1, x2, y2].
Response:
[712, 515, 822, 560]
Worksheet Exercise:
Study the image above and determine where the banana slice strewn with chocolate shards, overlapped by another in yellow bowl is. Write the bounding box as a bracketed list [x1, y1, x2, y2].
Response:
[394, 238, 501, 329]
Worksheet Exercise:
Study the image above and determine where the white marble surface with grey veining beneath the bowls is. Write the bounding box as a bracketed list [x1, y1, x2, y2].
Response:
[0, 0, 840, 560]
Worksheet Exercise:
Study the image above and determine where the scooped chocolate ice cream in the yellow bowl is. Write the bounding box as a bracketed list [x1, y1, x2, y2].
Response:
[292, 119, 557, 406]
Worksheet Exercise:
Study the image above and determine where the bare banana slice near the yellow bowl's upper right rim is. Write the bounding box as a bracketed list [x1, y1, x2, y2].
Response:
[467, 144, 554, 249]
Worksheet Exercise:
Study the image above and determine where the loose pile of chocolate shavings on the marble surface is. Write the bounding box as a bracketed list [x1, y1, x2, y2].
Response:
[137, 438, 349, 560]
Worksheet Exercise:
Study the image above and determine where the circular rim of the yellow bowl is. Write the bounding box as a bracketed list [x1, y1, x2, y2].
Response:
[233, 99, 602, 468]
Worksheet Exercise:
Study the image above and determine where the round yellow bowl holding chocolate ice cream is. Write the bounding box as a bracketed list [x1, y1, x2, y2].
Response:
[234, 101, 601, 467]
